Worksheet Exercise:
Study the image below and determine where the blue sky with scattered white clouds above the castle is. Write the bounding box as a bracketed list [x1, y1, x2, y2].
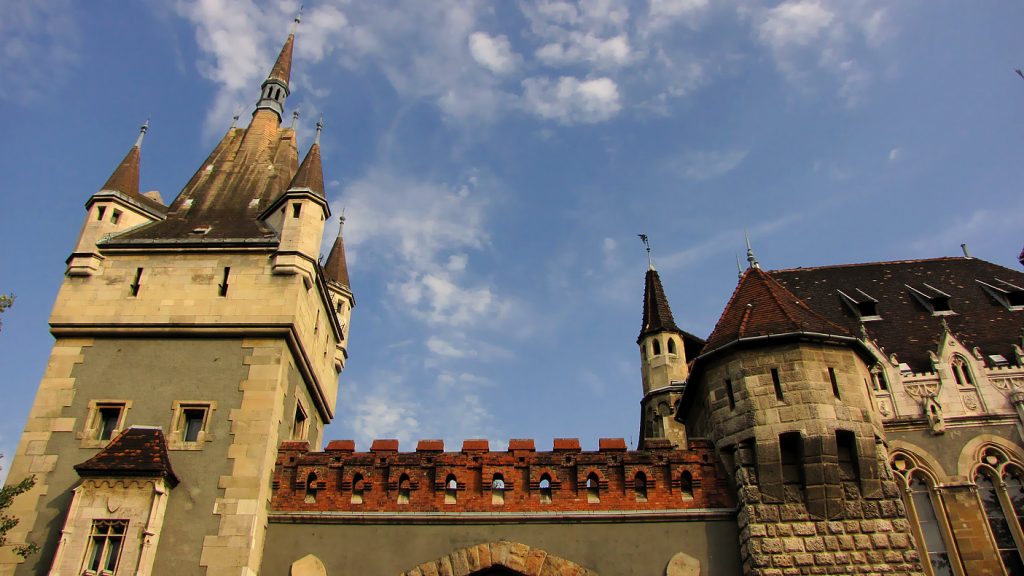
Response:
[0, 0, 1024, 455]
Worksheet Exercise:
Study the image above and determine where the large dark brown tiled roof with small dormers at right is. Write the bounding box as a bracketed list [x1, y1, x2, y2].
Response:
[769, 257, 1024, 372]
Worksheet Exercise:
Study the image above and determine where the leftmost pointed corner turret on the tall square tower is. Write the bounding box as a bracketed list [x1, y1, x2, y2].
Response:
[67, 121, 167, 276]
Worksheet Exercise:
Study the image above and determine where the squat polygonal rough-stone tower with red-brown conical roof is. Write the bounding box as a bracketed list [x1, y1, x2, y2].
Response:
[680, 265, 922, 575]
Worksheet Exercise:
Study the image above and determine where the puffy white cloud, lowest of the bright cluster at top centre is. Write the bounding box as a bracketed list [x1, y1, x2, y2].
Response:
[522, 76, 623, 124]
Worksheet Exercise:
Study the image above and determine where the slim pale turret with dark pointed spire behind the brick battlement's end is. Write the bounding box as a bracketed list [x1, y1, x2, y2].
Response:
[637, 264, 688, 450]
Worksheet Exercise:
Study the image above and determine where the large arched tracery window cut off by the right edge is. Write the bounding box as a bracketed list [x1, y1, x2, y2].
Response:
[974, 448, 1024, 576]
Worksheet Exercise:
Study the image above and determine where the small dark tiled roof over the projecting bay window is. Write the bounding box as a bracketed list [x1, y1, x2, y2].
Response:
[75, 426, 178, 486]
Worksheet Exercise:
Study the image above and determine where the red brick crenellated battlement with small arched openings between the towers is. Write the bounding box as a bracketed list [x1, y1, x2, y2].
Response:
[271, 438, 735, 512]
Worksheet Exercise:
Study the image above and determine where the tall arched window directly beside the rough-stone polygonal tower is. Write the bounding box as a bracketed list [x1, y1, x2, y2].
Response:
[890, 452, 962, 576]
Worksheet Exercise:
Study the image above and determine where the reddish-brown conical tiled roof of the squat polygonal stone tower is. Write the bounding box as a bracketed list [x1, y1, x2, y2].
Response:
[701, 268, 853, 354]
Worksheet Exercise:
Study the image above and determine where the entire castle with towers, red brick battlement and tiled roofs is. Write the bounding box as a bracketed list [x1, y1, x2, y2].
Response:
[0, 23, 1024, 576]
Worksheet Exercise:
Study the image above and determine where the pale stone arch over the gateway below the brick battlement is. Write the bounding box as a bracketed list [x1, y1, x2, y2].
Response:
[401, 540, 597, 576]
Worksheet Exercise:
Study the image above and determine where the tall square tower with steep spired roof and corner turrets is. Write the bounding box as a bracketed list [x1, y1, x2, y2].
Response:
[0, 22, 354, 576]
